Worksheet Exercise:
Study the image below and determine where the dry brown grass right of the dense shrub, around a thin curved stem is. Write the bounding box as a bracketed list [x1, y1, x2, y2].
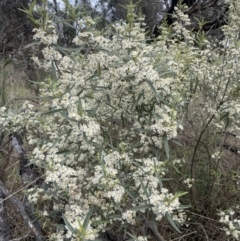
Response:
[167, 93, 240, 241]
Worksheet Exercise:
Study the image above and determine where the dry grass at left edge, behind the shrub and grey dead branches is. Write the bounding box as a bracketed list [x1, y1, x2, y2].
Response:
[0, 59, 38, 240]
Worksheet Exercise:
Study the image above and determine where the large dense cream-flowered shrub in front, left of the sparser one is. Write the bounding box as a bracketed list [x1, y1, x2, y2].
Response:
[1, 1, 188, 240]
